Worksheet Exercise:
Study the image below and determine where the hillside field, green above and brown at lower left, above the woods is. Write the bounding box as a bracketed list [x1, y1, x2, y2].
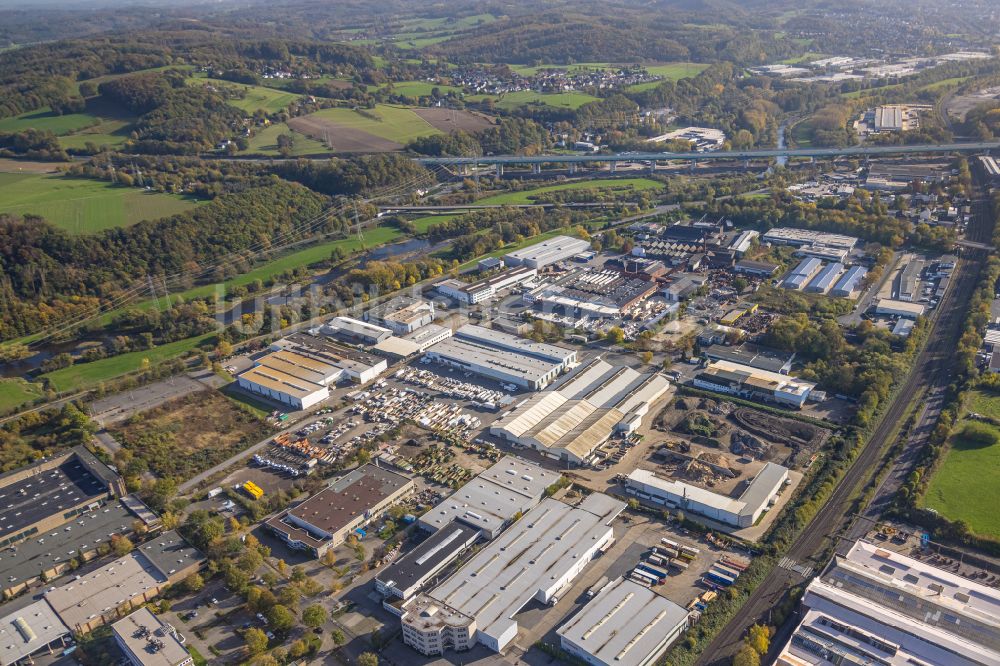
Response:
[288, 104, 439, 153]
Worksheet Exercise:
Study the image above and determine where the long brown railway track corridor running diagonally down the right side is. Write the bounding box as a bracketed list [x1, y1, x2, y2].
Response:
[697, 192, 992, 665]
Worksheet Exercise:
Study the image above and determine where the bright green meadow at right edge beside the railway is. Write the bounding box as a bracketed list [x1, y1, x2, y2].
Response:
[920, 418, 1000, 539]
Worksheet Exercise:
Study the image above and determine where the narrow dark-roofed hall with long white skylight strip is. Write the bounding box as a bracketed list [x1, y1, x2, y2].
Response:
[375, 521, 482, 607]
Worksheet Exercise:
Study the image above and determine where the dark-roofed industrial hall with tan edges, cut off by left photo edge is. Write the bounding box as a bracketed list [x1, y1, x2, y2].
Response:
[0, 446, 126, 552]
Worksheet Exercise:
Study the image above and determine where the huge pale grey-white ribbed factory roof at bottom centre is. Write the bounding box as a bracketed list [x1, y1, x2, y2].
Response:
[427, 493, 625, 643]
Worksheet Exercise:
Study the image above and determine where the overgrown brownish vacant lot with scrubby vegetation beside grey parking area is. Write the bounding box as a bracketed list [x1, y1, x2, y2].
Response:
[114, 391, 269, 479]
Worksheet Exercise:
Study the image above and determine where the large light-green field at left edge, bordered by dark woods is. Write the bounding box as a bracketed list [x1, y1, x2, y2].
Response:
[0, 173, 201, 234]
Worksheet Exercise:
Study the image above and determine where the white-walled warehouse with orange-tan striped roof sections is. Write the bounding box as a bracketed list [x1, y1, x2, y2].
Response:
[236, 333, 389, 409]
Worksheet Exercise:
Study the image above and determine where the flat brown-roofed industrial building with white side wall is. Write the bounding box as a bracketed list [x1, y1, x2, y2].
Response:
[264, 465, 415, 557]
